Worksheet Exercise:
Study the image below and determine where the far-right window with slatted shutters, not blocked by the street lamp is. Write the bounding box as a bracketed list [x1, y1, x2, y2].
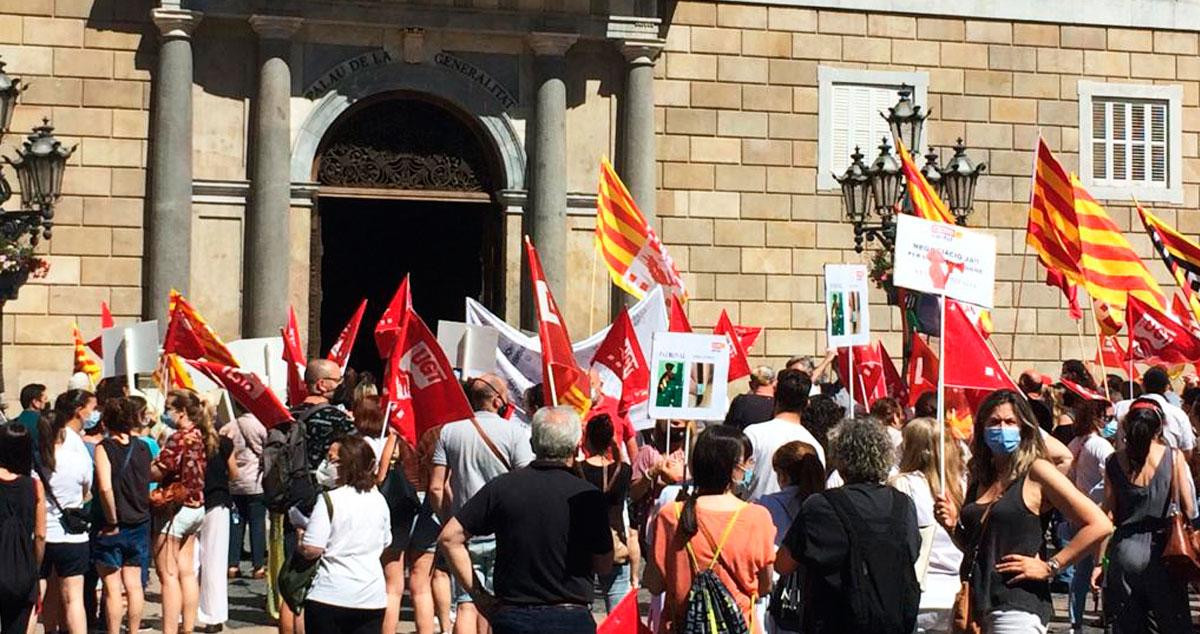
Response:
[1079, 82, 1183, 202]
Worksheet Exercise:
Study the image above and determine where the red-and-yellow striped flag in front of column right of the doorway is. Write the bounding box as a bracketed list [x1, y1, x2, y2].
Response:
[595, 159, 688, 301]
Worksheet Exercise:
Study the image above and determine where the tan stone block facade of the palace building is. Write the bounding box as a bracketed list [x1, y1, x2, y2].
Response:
[0, 0, 1200, 397]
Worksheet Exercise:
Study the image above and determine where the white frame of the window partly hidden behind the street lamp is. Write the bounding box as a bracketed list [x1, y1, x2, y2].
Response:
[817, 66, 929, 191]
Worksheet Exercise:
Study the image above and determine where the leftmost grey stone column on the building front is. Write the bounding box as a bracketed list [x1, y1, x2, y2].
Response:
[142, 8, 203, 325]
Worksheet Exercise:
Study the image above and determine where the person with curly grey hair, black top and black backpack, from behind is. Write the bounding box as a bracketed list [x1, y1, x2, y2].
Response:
[775, 417, 920, 634]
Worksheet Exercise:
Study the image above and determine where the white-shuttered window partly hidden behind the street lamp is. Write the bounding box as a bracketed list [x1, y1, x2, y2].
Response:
[817, 66, 929, 190]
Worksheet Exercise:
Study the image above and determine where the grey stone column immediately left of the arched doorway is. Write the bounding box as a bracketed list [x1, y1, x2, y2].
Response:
[241, 16, 301, 337]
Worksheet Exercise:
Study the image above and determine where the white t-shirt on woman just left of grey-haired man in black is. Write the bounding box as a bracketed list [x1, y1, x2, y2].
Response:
[304, 486, 391, 610]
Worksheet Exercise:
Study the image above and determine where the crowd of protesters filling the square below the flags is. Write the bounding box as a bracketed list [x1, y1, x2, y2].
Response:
[0, 355, 1200, 634]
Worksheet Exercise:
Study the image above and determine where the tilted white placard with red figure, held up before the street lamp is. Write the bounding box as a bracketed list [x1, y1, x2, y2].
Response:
[893, 214, 996, 309]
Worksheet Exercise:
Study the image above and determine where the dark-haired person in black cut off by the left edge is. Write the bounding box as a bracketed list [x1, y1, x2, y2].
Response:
[0, 423, 47, 634]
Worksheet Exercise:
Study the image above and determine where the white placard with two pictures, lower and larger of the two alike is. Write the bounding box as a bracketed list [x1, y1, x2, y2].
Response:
[650, 333, 730, 420]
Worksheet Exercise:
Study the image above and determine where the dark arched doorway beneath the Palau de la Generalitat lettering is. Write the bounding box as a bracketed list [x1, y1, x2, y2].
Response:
[310, 92, 504, 377]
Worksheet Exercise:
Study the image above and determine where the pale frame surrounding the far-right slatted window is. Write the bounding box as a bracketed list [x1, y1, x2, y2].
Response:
[1079, 79, 1183, 204]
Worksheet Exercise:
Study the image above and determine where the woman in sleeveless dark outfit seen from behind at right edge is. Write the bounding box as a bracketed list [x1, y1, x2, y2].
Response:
[1098, 397, 1196, 633]
